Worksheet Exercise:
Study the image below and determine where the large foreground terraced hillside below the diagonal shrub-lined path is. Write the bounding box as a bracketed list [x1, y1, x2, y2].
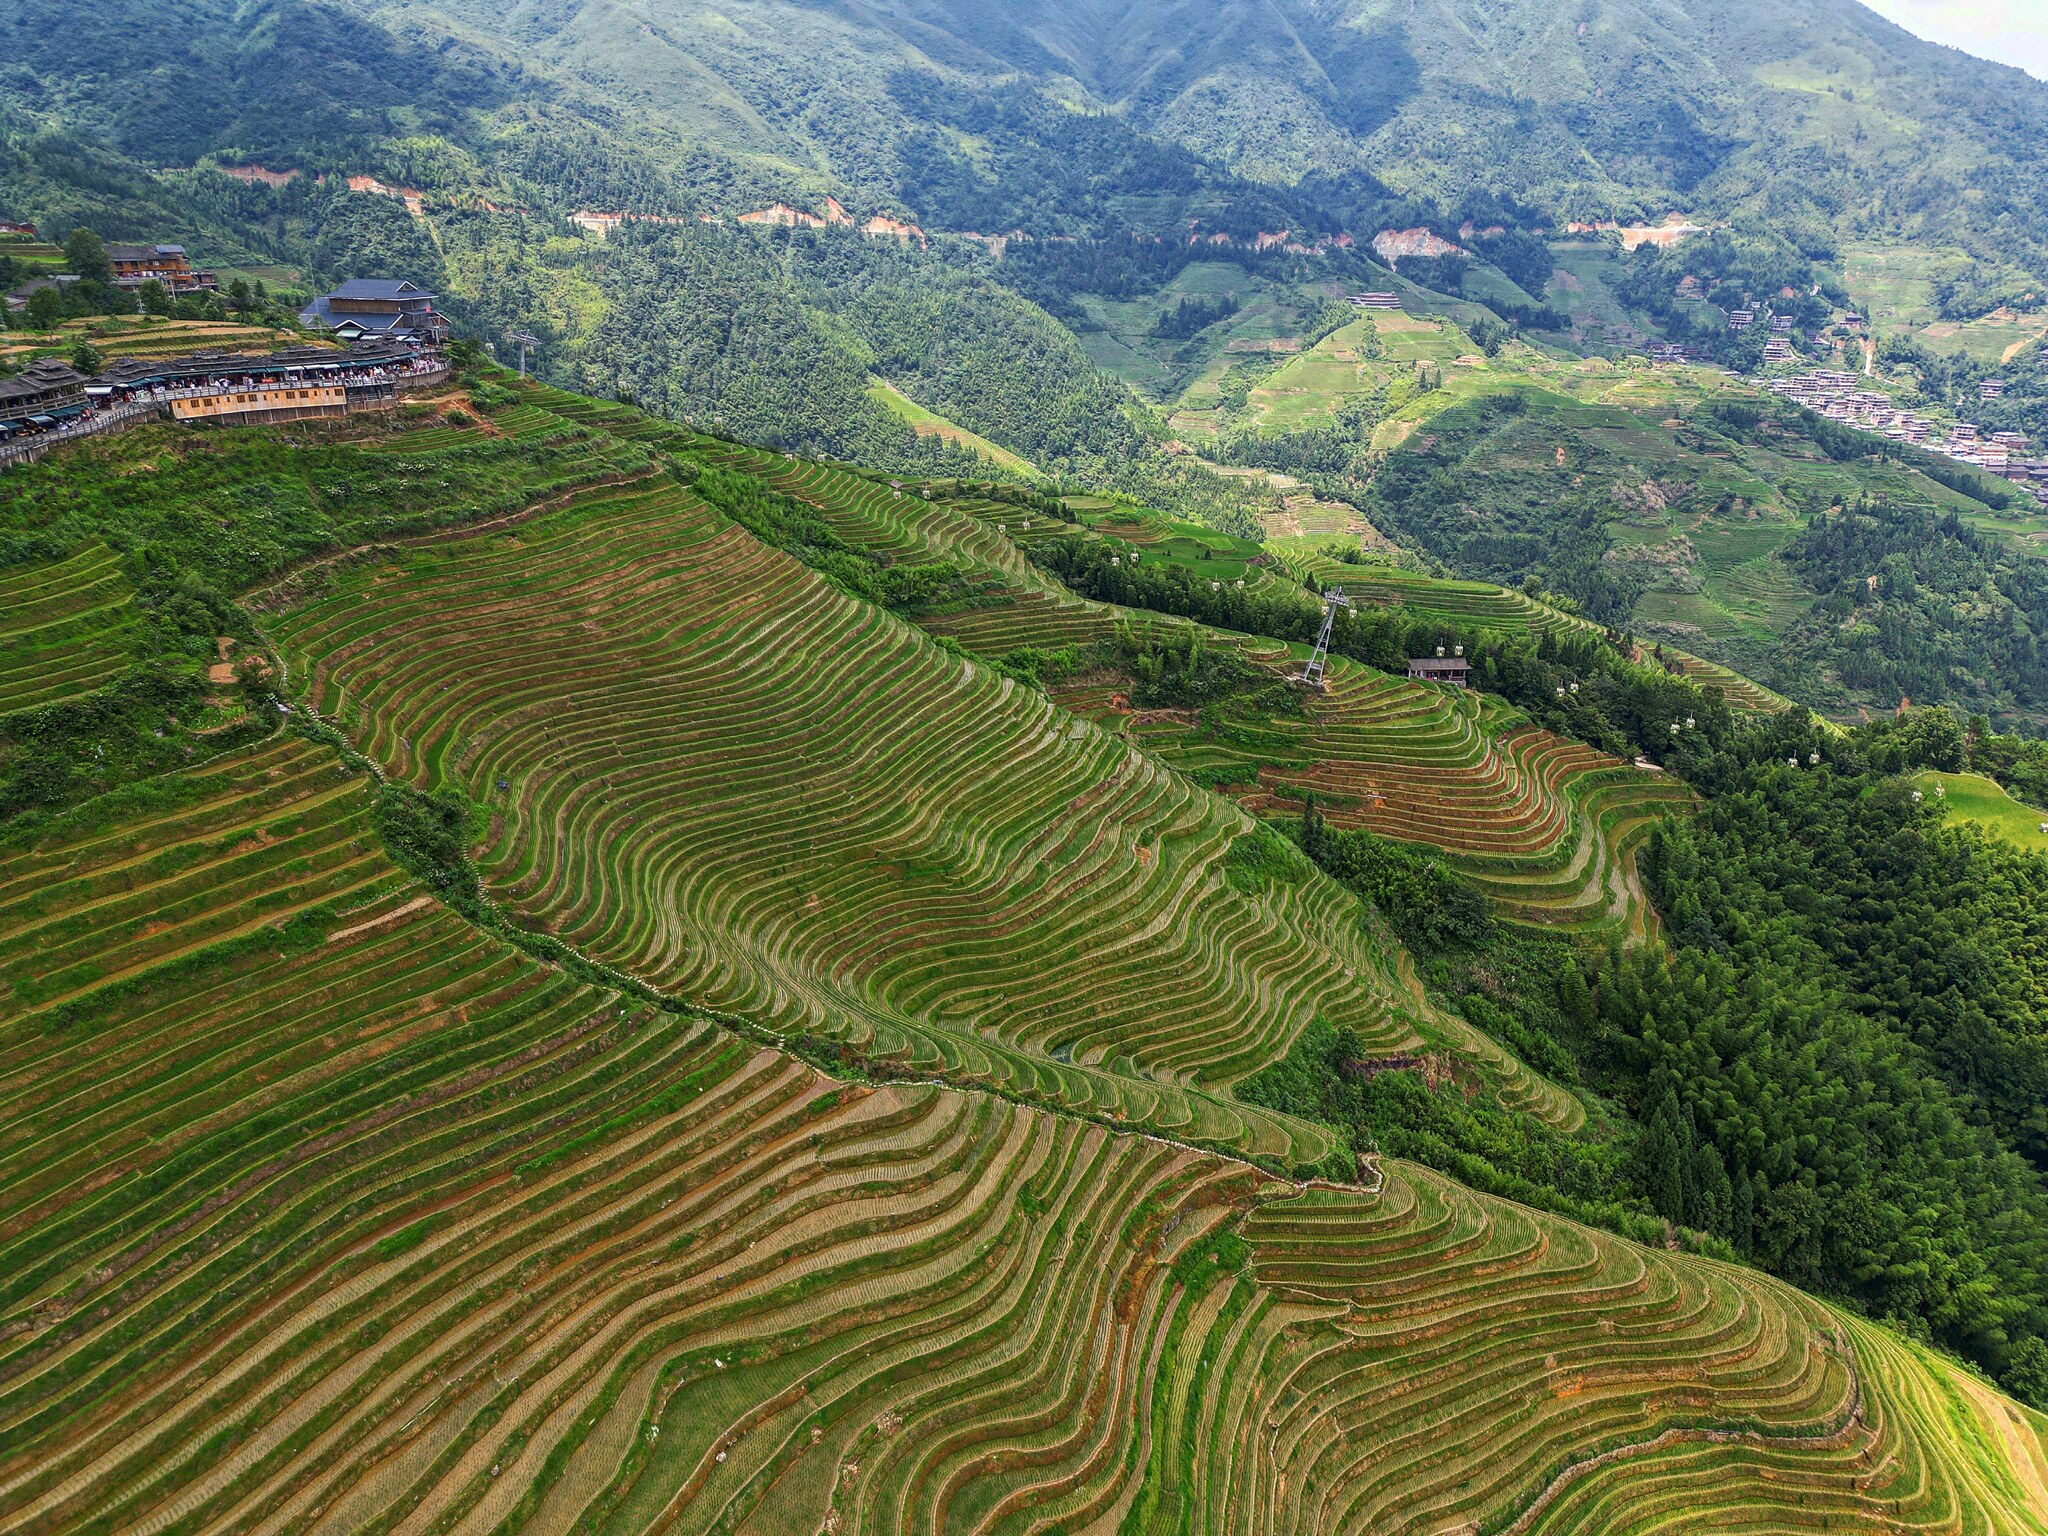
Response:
[0, 739, 2044, 1536]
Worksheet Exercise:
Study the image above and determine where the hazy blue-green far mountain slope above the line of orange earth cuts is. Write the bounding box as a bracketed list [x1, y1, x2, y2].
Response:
[0, 0, 2048, 268]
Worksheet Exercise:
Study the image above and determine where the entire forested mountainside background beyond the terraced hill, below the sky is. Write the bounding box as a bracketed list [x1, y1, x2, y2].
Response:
[0, 0, 2048, 729]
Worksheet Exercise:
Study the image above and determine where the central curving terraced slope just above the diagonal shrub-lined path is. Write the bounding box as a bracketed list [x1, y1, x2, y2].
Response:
[274, 475, 1415, 1157]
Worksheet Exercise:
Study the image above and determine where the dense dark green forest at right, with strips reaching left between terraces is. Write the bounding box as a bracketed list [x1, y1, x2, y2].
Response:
[1245, 696, 2048, 1403]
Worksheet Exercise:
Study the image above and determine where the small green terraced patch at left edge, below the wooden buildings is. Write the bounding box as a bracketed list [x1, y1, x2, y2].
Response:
[0, 543, 139, 715]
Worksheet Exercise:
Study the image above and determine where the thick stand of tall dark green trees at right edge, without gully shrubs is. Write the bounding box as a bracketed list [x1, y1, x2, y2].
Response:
[1613, 721, 2048, 1403]
